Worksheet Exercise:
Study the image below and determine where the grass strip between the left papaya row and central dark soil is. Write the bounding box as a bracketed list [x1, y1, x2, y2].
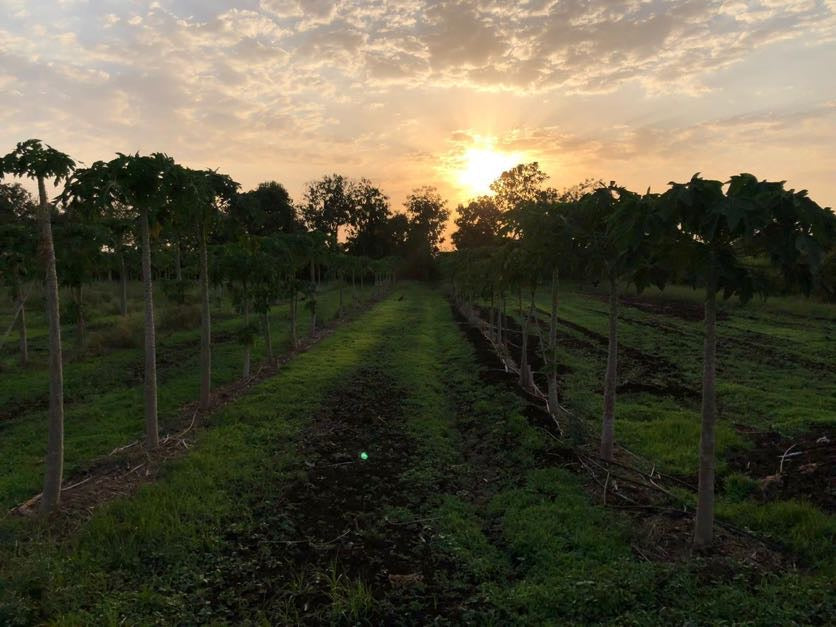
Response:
[0, 286, 397, 624]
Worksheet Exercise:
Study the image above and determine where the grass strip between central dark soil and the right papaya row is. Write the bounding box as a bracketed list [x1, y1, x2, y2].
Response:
[388, 288, 833, 624]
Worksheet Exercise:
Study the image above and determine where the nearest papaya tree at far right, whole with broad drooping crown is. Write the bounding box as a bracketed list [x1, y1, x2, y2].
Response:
[660, 174, 836, 548]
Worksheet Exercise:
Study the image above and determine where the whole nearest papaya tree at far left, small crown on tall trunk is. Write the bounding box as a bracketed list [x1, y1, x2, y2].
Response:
[0, 139, 75, 514]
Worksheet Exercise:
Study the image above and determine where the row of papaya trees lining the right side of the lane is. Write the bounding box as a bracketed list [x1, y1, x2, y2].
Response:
[447, 163, 836, 547]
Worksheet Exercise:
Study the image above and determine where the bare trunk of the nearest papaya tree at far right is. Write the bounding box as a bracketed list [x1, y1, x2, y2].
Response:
[694, 277, 717, 547]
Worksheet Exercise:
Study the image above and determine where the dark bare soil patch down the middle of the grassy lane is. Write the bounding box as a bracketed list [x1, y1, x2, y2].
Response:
[198, 367, 490, 624]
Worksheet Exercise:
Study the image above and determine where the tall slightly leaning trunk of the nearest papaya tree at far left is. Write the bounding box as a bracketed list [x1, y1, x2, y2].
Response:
[38, 177, 64, 514]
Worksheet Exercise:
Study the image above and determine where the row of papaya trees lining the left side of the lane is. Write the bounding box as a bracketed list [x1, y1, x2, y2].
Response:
[0, 140, 398, 513]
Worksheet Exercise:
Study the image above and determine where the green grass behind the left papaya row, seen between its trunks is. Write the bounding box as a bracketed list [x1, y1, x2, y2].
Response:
[0, 285, 371, 509]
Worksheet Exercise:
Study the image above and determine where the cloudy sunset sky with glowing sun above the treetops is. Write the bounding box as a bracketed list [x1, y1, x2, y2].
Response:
[0, 0, 836, 228]
